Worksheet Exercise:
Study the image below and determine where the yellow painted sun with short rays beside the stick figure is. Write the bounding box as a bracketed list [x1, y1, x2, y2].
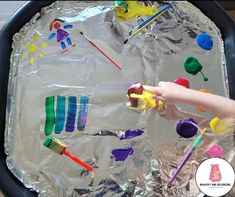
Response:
[22, 34, 47, 64]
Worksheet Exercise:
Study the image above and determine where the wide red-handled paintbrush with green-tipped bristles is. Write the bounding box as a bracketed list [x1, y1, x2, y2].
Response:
[43, 137, 94, 172]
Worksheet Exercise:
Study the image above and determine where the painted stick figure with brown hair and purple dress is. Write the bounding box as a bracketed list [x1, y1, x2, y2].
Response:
[48, 18, 75, 49]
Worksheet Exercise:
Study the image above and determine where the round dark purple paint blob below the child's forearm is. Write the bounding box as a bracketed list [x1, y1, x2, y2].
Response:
[176, 118, 198, 138]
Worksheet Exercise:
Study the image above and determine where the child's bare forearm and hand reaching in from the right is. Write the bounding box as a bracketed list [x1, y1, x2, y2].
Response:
[144, 82, 235, 118]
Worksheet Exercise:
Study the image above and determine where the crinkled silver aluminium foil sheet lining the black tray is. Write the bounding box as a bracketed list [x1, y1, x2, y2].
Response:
[5, 1, 234, 197]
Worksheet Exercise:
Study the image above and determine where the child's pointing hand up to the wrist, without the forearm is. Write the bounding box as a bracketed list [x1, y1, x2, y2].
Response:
[145, 81, 189, 104]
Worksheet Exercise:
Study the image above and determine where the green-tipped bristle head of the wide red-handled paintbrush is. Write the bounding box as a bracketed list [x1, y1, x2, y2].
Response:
[43, 137, 66, 154]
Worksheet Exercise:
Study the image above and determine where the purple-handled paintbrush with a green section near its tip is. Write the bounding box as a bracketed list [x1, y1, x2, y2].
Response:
[167, 129, 206, 186]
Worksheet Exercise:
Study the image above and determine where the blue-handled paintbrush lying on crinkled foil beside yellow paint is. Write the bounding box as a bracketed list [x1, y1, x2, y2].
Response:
[124, 3, 173, 44]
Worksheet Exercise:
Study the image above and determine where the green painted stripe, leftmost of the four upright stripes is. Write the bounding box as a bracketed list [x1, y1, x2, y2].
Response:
[44, 96, 55, 136]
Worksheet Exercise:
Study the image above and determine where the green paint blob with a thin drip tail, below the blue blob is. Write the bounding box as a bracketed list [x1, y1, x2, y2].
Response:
[184, 57, 208, 81]
